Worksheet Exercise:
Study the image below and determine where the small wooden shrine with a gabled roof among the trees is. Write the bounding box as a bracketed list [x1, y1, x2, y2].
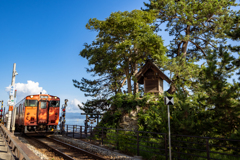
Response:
[136, 60, 171, 94]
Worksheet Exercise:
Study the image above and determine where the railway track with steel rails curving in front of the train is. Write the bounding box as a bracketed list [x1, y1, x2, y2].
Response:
[25, 137, 106, 160]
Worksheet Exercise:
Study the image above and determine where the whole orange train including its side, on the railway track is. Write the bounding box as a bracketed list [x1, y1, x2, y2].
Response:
[15, 93, 60, 133]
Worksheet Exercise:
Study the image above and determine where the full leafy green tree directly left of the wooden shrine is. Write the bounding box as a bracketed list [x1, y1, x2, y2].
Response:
[80, 10, 166, 93]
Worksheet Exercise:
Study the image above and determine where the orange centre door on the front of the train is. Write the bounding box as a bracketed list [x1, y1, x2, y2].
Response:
[38, 101, 48, 124]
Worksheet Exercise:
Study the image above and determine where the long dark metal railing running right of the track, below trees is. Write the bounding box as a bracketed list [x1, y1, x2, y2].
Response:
[65, 125, 240, 160]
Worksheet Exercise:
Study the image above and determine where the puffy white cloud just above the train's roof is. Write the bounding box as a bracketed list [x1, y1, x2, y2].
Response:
[5, 80, 47, 101]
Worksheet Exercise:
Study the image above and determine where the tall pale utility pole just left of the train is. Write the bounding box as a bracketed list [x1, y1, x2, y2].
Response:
[7, 63, 18, 131]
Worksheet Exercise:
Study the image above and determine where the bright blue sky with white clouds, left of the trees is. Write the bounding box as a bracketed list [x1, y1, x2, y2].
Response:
[0, 0, 237, 112]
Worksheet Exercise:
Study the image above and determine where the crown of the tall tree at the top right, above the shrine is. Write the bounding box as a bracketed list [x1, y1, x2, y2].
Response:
[144, 0, 237, 60]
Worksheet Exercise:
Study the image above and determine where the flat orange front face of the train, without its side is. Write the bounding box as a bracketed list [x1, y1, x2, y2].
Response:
[24, 94, 60, 133]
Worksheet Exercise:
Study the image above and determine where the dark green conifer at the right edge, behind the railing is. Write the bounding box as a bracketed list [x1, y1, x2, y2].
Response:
[198, 46, 240, 138]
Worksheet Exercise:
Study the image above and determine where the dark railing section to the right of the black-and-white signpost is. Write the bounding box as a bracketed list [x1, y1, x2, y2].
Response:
[171, 134, 240, 160]
